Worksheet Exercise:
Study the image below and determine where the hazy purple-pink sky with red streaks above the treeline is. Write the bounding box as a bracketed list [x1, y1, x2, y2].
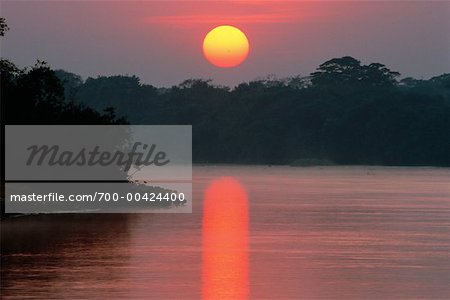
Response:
[0, 0, 450, 87]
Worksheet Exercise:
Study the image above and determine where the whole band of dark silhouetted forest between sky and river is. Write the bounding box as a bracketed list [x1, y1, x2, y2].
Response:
[0, 17, 450, 166]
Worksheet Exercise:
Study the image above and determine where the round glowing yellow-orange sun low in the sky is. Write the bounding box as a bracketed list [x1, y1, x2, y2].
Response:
[203, 25, 250, 68]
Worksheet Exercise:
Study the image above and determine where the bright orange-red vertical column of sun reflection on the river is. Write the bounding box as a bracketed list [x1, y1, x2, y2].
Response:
[202, 177, 249, 300]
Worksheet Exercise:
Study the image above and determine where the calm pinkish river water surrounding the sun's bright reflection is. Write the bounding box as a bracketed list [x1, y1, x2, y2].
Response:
[1, 166, 450, 299]
